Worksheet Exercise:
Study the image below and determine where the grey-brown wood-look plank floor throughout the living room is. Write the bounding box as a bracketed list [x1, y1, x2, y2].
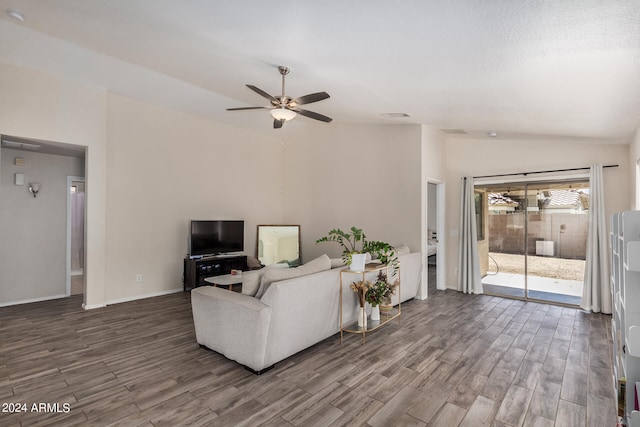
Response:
[0, 272, 616, 427]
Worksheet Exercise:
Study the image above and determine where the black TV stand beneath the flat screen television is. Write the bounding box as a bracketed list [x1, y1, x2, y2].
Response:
[183, 255, 247, 291]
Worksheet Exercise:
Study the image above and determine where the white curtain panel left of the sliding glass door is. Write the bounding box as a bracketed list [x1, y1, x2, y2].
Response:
[458, 177, 482, 294]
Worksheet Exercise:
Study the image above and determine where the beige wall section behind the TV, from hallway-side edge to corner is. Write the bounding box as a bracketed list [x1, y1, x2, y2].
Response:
[106, 94, 283, 302]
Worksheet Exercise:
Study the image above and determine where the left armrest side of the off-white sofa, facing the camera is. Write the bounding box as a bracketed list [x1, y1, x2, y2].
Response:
[191, 286, 271, 371]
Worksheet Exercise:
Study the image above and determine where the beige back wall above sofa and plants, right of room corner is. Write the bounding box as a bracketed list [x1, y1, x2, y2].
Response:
[282, 122, 421, 262]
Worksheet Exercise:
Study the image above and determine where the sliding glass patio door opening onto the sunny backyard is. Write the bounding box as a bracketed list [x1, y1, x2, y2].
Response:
[476, 179, 589, 306]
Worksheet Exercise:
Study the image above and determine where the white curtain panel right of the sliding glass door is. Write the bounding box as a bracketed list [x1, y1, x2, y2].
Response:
[580, 165, 611, 314]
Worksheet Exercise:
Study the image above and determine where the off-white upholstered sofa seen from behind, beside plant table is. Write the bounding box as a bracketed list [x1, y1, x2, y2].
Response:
[191, 252, 422, 373]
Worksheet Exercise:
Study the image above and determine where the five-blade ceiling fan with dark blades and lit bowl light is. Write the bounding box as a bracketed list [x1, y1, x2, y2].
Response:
[227, 66, 333, 129]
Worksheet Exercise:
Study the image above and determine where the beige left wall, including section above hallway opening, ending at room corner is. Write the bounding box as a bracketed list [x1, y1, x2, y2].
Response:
[0, 59, 283, 308]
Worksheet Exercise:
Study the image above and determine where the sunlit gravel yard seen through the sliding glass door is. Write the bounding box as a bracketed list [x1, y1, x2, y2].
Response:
[489, 252, 585, 280]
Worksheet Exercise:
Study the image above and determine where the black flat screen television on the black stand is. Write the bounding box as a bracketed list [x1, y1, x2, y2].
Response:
[189, 220, 244, 258]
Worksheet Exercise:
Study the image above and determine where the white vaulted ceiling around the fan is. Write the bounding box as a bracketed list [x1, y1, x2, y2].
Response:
[0, 0, 640, 142]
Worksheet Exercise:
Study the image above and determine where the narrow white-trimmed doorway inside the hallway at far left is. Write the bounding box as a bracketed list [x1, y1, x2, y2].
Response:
[67, 176, 86, 296]
